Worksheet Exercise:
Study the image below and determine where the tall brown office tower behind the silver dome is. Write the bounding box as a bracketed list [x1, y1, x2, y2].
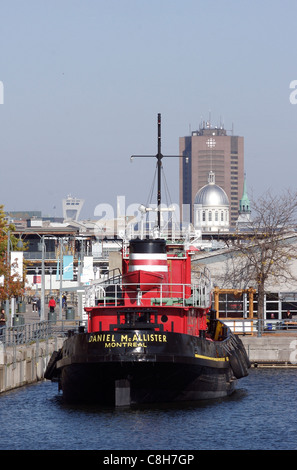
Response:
[179, 122, 244, 227]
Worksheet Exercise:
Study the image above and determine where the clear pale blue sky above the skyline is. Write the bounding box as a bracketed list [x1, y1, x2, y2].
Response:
[0, 0, 297, 217]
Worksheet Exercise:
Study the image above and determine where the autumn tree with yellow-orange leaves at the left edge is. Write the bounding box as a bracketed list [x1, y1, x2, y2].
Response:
[0, 205, 24, 301]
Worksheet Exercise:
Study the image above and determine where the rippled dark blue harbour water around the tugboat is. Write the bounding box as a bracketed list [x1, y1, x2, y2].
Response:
[0, 368, 297, 451]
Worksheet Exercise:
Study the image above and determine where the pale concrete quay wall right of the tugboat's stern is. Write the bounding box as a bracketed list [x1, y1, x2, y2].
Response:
[240, 331, 297, 367]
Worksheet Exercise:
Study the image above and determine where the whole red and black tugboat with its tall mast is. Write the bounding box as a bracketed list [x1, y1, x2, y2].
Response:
[45, 115, 250, 406]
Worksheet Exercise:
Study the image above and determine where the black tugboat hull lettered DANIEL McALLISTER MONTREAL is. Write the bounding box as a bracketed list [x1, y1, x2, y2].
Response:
[45, 330, 249, 406]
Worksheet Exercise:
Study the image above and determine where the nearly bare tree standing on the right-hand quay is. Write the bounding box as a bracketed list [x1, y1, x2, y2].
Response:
[220, 191, 297, 334]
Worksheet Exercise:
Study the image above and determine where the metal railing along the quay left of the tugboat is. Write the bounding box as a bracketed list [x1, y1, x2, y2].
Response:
[0, 320, 84, 347]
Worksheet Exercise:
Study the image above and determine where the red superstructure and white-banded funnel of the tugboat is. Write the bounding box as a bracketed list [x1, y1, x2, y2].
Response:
[86, 239, 211, 336]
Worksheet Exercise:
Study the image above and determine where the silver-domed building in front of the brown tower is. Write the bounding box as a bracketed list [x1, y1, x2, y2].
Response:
[194, 171, 230, 232]
